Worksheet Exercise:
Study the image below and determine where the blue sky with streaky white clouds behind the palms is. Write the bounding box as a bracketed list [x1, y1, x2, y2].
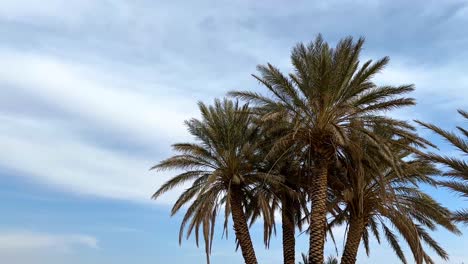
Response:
[0, 0, 468, 264]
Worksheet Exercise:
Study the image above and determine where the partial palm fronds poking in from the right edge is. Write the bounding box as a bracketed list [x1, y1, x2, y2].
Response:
[416, 110, 468, 224]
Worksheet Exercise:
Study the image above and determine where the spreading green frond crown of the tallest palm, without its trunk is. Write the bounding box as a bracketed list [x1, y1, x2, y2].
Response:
[230, 35, 420, 165]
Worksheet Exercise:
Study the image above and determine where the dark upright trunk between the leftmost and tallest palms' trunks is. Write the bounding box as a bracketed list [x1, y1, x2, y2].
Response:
[281, 197, 296, 264]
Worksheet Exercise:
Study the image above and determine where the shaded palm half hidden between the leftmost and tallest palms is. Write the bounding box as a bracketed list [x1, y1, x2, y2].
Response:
[245, 118, 307, 264]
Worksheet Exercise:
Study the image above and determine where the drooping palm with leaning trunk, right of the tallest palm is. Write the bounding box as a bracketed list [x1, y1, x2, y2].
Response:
[329, 129, 459, 264]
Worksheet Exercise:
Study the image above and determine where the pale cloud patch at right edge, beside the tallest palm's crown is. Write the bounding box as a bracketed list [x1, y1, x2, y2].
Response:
[374, 56, 468, 124]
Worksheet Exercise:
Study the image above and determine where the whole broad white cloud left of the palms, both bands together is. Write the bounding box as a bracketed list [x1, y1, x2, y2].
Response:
[0, 51, 196, 205]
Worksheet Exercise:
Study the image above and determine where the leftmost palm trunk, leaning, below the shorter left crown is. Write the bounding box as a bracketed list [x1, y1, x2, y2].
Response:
[230, 186, 257, 264]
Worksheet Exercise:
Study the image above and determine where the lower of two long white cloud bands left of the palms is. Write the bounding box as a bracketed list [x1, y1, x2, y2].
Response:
[0, 113, 183, 202]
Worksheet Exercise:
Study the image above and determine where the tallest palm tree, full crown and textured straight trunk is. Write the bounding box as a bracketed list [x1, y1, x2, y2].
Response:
[230, 35, 414, 264]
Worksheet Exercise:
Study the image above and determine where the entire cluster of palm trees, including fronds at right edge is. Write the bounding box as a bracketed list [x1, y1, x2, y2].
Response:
[153, 35, 468, 264]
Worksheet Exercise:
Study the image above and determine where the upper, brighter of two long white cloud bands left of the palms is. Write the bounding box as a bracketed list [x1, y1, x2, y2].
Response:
[0, 50, 195, 145]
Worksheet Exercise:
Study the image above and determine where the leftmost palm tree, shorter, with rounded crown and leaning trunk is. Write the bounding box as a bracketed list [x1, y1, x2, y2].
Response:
[153, 99, 277, 264]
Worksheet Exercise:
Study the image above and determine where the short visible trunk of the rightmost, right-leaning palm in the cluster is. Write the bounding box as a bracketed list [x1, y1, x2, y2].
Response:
[341, 216, 364, 264]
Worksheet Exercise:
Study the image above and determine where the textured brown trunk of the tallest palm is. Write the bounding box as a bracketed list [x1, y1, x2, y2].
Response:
[309, 165, 328, 264]
